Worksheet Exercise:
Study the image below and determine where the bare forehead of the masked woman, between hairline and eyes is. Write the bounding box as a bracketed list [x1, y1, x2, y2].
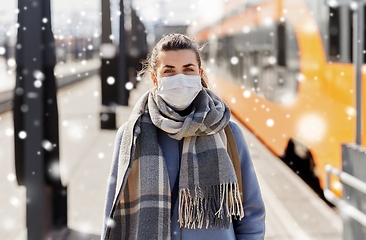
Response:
[158, 49, 198, 67]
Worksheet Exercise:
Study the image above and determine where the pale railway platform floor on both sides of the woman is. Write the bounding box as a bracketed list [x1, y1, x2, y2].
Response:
[0, 75, 342, 240]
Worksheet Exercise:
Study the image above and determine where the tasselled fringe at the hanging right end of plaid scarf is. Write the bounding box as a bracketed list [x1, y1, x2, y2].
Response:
[178, 183, 244, 229]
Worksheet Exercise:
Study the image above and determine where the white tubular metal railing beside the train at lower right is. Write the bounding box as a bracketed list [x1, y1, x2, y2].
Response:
[324, 164, 366, 227]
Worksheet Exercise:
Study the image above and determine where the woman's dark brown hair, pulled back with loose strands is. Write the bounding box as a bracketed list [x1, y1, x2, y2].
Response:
[139, 33, 208, 88]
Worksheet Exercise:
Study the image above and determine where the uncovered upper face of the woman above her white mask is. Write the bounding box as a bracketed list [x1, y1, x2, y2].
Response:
[151, 49, 203, 87]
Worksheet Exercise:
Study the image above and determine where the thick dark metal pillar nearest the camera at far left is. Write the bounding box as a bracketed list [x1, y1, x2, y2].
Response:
[13, 0, 67, 240]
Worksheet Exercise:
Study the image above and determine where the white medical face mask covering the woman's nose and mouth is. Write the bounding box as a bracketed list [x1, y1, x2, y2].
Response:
[157, 73, 202, 110]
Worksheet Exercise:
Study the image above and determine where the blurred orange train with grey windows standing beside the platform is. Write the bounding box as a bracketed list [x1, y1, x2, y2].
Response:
[188, 0, 366, 195]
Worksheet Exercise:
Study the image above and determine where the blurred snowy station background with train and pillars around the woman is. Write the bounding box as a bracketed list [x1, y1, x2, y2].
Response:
[0, 0, 366, 240]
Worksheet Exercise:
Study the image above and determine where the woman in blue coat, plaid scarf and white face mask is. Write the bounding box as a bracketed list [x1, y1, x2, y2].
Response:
[102, 34, 265, 240]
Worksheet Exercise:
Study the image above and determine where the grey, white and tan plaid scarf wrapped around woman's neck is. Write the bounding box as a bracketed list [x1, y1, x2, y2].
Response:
[105, 89, 244, 240]
